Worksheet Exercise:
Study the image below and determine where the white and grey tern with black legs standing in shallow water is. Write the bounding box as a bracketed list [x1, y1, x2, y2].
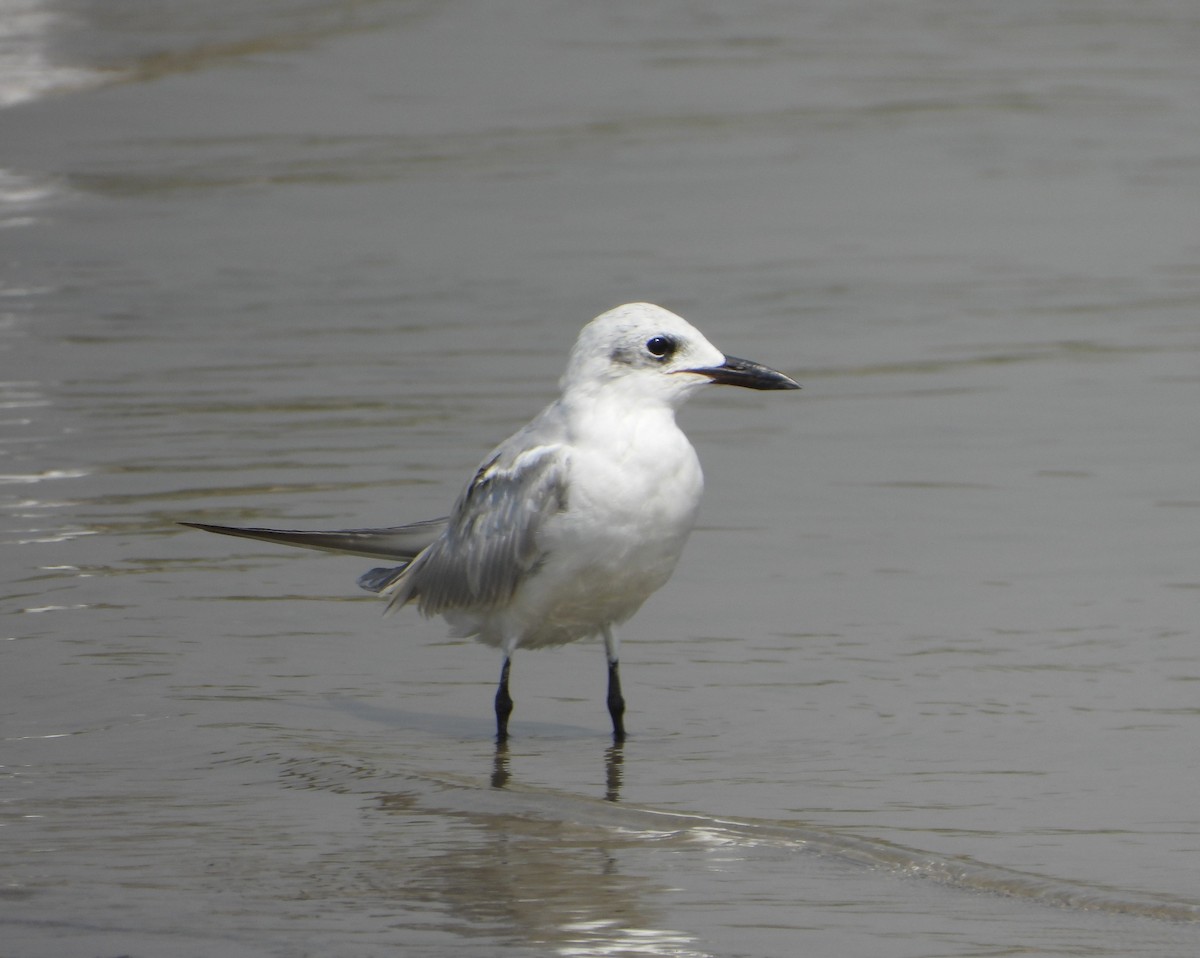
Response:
[182, 303, 800, 744]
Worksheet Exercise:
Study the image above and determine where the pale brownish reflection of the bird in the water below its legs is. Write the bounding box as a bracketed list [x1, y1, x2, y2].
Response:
[376, 773, 710, 958]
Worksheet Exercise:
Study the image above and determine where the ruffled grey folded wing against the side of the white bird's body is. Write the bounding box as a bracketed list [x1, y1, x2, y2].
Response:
[384, 433, 568, 616]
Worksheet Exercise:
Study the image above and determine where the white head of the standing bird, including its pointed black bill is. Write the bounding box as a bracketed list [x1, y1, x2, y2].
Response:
[562, 303, 799, 408]
